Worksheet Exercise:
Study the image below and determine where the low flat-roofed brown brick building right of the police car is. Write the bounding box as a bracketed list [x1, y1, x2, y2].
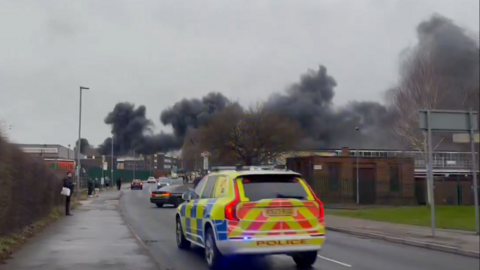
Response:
[287, 148, 416, 205]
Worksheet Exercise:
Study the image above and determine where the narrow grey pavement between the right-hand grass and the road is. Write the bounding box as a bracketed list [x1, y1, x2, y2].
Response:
[325, 215, 480, 258]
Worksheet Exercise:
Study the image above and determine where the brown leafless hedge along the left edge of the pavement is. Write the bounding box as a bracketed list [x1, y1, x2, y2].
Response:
[0, 136, 64, 238]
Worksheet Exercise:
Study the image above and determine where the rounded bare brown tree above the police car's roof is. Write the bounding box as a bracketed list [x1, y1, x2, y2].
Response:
[201, 106, 301, 166]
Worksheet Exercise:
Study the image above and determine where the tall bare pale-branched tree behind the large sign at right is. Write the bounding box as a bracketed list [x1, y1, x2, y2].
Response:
[389, 47, 479, 202]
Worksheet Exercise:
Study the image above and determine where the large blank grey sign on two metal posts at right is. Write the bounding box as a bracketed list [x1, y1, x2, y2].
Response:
[418, 109, 480, 236]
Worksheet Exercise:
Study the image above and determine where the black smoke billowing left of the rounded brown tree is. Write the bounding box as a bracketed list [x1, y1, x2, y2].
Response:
[99, 92, 232, 155]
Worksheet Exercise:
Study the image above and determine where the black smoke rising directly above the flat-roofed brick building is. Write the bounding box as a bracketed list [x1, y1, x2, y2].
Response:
[265, 66, 394, 149]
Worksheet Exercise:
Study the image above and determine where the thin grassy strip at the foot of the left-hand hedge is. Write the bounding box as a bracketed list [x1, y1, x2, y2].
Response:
[0, 207, 63, 264]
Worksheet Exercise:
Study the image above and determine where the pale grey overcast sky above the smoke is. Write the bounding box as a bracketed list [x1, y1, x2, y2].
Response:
[0, 0, 479, 148]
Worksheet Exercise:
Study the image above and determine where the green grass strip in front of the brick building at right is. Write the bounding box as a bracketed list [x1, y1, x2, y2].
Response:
[325, 206, 475, 231]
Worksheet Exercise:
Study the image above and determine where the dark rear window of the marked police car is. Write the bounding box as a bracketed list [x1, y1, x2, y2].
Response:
[242, 175, 308, 201]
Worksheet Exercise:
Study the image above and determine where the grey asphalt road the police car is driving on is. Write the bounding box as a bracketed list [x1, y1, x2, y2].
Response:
[120, 181, 479, 270]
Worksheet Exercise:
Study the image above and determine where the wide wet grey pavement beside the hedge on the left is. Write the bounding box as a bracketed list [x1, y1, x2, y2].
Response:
[0, 187, 158, 270]
